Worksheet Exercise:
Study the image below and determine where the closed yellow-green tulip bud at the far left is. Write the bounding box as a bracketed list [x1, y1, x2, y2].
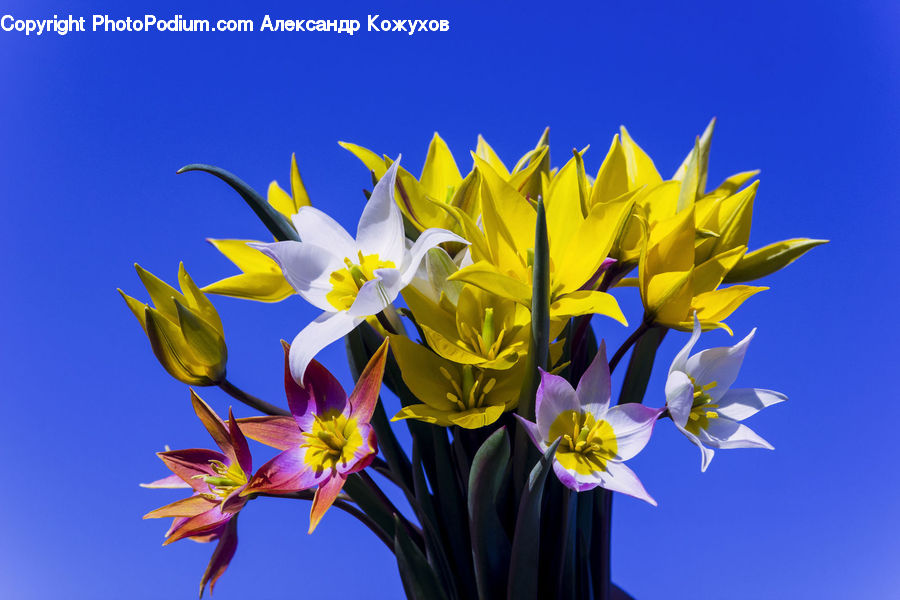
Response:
[119, 264, 228, 385]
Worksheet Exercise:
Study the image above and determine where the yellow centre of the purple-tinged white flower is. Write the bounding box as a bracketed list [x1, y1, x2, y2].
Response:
[550, 410, 619, 475]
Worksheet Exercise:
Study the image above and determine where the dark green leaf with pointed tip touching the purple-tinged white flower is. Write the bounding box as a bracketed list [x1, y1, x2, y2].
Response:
[506, 438, 561, 600]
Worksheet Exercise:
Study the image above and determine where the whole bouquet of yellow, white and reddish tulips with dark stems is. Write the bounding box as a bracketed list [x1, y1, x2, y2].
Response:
[122, 121, 824, 600]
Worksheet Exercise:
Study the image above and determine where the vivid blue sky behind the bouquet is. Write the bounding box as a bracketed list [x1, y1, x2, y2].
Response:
[0, 1, 900, 600]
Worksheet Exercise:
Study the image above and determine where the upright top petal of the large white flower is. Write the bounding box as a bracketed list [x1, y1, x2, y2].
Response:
[356, 158, 406, 267]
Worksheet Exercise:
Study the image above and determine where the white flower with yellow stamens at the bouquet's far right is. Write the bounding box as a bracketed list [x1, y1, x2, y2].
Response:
[666, 316, 787, 471]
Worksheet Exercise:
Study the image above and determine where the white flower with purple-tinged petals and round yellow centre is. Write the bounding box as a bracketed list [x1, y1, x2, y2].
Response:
[516, 343, 663, 506]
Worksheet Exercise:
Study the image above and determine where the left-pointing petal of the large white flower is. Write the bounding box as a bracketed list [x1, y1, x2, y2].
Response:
[247, 242, 344, 312]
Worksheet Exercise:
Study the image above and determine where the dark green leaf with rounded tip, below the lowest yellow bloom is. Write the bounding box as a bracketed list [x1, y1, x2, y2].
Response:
[469, 427, 510, 600]
